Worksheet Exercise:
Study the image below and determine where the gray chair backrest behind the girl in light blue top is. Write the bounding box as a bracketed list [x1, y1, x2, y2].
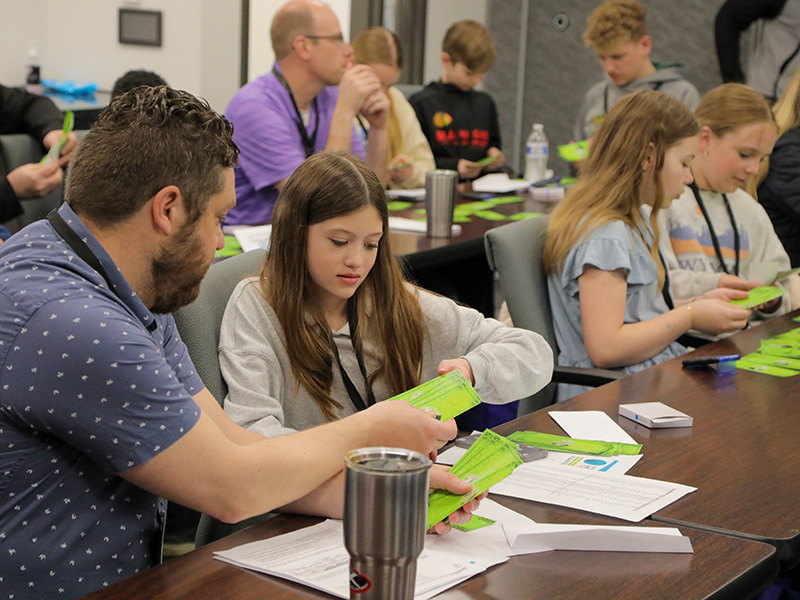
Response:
[484, 216, 558, 414]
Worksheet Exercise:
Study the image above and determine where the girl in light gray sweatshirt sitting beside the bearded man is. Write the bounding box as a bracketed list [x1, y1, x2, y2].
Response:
[220, 152, 552, 436]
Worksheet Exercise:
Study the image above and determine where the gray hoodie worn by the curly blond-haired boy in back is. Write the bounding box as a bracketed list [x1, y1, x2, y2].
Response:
[573, 66, 700, 142]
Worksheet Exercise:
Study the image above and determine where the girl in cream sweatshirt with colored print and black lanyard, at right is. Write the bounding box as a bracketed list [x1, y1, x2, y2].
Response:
[658, 83, 791, 316]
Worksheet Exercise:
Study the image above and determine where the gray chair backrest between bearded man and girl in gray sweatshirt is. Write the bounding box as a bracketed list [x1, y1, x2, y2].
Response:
[174, 249, 267, 405]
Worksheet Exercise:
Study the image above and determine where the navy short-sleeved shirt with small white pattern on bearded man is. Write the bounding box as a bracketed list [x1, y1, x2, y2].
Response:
[0, 205, 203, 600]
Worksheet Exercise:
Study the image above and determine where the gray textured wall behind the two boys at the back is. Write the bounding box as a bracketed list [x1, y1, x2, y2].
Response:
[485, 0, 724, 174]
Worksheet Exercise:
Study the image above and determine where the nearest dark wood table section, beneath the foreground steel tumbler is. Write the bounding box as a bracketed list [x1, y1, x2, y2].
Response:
[79, 497, 778, 600]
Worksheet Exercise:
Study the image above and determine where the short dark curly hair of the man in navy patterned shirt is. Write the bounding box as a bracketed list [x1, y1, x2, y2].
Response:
[64, 86, 239, 226]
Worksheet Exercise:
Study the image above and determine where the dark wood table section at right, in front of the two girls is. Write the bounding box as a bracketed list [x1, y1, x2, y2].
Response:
[498, 311, 800, 569]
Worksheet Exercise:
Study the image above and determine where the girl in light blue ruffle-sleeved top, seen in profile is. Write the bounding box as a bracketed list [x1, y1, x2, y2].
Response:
[544, 90, 749, 399]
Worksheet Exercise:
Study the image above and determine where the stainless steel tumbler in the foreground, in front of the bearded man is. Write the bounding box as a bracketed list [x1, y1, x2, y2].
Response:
[344, 448, 431, 600]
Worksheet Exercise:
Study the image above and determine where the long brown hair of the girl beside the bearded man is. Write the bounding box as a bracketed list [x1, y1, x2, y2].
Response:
[261, 152, 423, 421]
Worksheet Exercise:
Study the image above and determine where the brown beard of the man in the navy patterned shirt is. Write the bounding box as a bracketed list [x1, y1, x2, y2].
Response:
[150, 223, 211, 314]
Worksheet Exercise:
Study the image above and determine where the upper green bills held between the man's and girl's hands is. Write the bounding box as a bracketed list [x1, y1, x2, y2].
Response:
[390, 370, 481, 421]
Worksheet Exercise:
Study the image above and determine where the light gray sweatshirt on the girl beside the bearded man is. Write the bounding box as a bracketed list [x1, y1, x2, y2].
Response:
[219, 278, 553, 437]
